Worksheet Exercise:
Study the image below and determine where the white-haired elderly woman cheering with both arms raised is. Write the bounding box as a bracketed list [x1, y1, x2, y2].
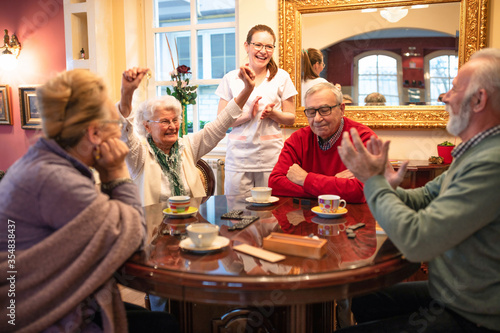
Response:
[118, 66, 255, 206]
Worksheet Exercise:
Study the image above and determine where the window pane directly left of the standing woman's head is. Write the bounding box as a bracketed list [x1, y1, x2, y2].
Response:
[198, 28, 236, 79]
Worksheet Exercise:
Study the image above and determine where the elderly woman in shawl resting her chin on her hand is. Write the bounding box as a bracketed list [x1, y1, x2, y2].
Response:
[0, 69, 178, 332]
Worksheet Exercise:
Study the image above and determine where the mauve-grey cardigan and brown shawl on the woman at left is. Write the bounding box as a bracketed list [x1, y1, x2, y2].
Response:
[0, 139, 145, 332]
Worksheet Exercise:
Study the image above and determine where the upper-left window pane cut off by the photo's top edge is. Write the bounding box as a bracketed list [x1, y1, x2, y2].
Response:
[154, 0, 191, 28]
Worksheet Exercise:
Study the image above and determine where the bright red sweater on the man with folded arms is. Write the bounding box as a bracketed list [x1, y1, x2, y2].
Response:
[269, 117, 375, 203]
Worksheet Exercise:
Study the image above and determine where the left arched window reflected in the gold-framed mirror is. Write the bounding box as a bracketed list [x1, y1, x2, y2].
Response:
[354, 50, 402, 105]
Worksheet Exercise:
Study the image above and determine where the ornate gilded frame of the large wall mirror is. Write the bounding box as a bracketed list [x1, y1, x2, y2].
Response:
[278, 0, 489, 129]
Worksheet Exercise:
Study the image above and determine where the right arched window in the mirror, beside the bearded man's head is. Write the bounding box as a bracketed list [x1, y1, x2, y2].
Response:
[424, 50, 458, 105]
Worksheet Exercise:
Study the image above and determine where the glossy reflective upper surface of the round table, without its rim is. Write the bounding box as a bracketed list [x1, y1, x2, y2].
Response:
[131, 196, 401, 276]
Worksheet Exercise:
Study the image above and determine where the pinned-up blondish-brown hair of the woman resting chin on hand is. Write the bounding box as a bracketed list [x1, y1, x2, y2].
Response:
[36, 69, 109, 148]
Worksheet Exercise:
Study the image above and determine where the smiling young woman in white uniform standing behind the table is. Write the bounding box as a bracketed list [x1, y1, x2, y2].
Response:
[215, 25, 297, 195]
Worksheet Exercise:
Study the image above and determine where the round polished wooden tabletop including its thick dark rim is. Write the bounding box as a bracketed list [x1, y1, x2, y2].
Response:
[124, 196, 419, 306]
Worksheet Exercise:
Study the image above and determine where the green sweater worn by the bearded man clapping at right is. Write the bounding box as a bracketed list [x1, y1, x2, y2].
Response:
[364, 135, 500, 330]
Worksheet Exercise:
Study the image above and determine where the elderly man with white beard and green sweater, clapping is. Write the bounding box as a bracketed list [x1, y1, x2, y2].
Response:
[339, 49, 500, 332]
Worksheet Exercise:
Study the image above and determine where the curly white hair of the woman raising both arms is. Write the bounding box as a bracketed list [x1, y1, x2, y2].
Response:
[134, 95, 182, 137]
